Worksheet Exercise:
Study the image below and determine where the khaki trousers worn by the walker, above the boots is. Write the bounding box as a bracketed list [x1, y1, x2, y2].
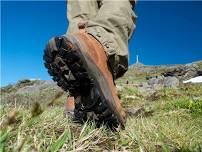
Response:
[67, 0, 136, 79]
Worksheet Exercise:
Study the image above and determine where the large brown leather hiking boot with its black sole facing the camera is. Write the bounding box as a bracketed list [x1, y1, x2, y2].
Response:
[44, 25, 125, 128]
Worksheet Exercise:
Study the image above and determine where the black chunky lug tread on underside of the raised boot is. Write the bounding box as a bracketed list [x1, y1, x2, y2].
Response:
[43, 37, 119, 128]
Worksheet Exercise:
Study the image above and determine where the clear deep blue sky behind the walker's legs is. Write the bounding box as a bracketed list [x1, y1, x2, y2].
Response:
[1, 1, 202, 86]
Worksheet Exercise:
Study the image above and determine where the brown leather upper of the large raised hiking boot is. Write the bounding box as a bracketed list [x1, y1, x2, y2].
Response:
[70, 26, 126, 127]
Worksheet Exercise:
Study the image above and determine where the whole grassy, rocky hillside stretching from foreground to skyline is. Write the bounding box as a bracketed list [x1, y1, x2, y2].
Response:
[0, 61, 202, 152]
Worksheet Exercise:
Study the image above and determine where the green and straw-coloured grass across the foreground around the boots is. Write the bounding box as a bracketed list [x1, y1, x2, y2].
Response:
[0, 81, 202, 152]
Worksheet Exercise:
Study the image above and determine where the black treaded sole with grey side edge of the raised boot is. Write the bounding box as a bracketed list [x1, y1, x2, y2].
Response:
[44, 37, 124, 127]
